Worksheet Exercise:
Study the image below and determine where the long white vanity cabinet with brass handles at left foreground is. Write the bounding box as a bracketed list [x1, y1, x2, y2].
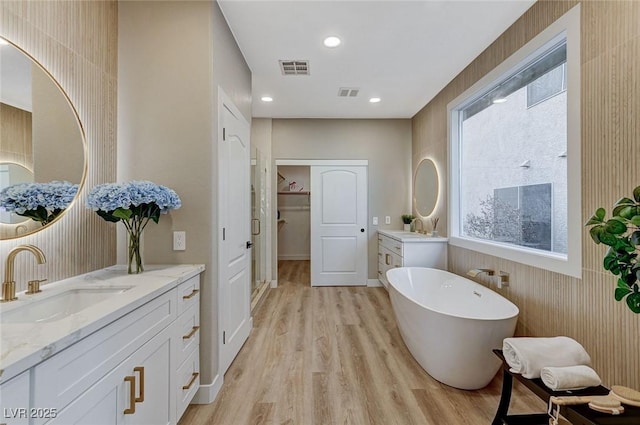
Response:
[0, 264, 200, 425]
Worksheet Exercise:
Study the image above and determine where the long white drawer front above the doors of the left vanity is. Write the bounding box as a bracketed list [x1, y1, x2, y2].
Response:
[33, 289, 177, 409]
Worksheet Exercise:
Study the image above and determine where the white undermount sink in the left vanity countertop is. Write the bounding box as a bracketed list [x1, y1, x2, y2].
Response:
[0, 286, 132, 323]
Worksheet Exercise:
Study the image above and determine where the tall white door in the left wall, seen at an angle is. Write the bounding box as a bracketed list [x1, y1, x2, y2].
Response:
[218, 94, 251, 374]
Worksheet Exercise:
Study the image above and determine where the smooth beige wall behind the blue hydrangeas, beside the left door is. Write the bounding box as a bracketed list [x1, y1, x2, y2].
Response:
[118, 1, 251, 385]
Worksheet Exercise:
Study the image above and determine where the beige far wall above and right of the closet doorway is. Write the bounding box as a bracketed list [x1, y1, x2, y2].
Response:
[272, 119, 411, 279]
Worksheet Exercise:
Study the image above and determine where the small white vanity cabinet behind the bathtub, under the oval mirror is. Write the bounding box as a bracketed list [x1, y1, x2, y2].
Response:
[378, 230, 448, 288]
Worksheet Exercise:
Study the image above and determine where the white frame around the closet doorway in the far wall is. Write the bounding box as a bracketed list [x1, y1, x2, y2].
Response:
[271, 158, 369, 288]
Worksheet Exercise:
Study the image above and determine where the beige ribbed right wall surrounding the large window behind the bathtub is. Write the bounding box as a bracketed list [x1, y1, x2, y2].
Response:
[412, 1, 640, 388]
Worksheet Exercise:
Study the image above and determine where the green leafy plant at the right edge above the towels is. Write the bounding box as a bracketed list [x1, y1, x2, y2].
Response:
[585, 186, 640, 314]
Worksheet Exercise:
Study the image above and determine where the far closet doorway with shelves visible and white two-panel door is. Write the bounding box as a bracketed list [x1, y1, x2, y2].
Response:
[275, 160, 368, 286]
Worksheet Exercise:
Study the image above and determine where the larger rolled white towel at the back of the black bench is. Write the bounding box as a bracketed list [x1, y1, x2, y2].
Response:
[502, 336, 591, 379]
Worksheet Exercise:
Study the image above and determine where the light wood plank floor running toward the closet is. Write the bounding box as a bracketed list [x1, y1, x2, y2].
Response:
[179, 261, 546, 425]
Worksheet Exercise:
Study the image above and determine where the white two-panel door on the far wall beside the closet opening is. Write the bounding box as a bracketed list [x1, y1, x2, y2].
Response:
[311, 166, 367, 286]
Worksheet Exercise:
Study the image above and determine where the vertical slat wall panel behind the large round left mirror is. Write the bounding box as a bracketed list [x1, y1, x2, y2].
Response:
[0, 0, 118, 291]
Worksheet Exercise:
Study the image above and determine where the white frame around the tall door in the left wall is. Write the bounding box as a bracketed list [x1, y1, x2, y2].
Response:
[215, 86, 253, 374]
